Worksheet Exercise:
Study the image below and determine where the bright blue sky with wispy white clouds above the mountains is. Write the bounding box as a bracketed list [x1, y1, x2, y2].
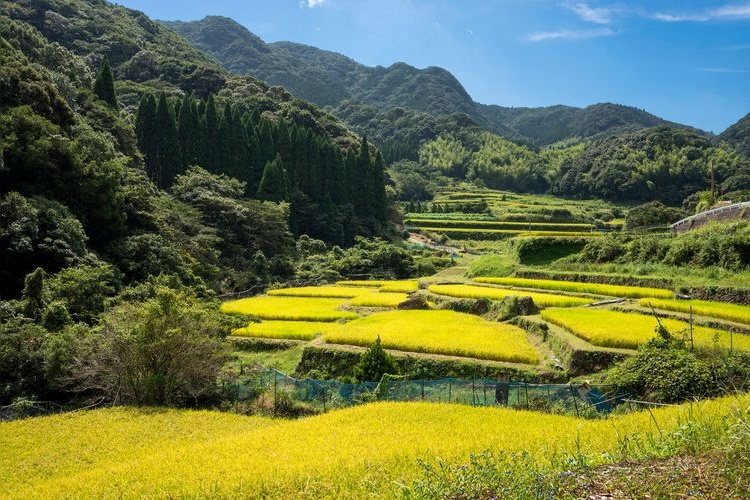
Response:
[116, 0, 750, 133]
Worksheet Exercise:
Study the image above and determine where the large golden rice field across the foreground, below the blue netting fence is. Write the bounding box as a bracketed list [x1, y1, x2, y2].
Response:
[0, 396, 750, 498]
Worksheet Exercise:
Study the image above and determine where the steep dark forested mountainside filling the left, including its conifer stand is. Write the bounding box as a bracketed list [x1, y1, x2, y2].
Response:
[0, 0, 389, 298]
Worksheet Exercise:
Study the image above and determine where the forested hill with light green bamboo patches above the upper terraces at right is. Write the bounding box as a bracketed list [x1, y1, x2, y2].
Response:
[419, 127, 750, 205]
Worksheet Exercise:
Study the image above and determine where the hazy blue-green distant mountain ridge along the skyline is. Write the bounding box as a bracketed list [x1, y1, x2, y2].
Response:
[163, 16, 690, 146]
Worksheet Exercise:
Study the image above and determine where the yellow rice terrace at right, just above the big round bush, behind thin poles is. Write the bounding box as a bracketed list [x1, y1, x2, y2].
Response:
[542, 309, 750, 351]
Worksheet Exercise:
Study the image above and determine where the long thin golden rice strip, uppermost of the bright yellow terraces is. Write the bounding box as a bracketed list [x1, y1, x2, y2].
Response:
[474, 277, 674, 299]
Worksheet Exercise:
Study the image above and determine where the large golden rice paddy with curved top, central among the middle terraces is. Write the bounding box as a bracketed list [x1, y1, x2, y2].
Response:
[324, 311, 537, 364]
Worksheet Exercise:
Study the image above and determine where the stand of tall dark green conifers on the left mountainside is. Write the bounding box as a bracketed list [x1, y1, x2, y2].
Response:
[136, 93, 388, 244]
